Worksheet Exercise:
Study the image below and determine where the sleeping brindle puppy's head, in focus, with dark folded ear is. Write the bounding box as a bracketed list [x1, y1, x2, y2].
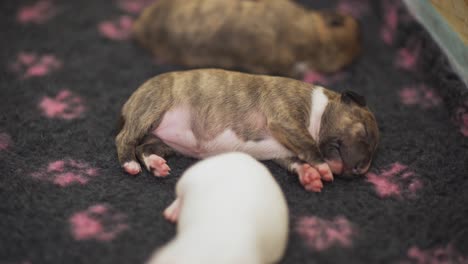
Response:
[319, 91, 379, 176]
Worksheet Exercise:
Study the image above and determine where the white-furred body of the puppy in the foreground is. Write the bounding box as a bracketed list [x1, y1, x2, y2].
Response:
[148, 153, 289, 264]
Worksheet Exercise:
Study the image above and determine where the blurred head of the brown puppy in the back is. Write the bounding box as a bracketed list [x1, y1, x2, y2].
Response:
[313, 11, 361, 72]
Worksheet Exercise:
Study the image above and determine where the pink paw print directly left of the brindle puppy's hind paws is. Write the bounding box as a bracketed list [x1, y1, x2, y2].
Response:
[31, 160, 98, 187]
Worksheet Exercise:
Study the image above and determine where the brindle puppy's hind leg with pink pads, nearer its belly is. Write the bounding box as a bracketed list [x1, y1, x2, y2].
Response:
[136, 135, 173, 177]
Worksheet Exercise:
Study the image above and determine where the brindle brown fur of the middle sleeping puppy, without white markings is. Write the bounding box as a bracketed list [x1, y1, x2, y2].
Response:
[116, 69, 378, 176]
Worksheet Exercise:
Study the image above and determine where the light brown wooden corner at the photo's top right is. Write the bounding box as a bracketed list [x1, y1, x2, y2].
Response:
[430, 0, 468, 45]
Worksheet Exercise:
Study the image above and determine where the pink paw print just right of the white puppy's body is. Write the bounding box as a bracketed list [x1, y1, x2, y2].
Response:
[296, 216, 356, 251]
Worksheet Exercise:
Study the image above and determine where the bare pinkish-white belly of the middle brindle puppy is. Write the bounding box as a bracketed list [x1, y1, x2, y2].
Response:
[153, 107, 292, 160]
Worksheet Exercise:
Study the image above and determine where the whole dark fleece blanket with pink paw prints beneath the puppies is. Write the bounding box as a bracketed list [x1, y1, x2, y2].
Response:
[0, 0, 468, 264]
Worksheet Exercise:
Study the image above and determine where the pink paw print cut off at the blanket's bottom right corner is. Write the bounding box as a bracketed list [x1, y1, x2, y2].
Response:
[400, 245, 468, 264]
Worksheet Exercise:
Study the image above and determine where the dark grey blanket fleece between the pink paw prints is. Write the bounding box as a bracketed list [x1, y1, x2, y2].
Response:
[0, 0, 468, 263]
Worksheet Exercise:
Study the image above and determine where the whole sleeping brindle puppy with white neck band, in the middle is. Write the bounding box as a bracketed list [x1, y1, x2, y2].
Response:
[116, 69, 379, 191]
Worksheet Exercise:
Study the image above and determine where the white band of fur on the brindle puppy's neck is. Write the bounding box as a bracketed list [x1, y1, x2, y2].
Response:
[309, 86, 328, 142]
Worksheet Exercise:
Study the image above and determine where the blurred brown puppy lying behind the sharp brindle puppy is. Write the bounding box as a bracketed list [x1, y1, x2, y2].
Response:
[134, 0, 360, 77]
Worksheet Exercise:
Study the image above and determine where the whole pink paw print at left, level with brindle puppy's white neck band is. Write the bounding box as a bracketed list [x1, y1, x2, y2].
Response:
[39, 89, 85, 120]
